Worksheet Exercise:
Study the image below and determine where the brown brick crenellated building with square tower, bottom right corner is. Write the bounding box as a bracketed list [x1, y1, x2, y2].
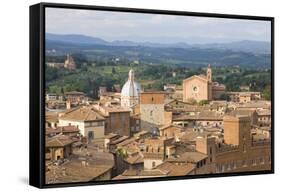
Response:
[196, 116, 271, 173]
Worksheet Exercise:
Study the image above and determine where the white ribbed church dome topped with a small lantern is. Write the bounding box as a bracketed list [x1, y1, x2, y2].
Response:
[121, 69, 141, 97]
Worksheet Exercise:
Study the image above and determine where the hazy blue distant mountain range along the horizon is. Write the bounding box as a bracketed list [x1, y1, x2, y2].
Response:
[46, 33, 271, 54]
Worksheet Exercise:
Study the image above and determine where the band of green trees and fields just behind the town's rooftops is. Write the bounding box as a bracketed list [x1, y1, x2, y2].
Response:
[45, 54, 271, 100]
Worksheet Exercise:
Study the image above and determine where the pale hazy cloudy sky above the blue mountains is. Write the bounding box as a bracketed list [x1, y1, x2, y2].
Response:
[46, 8, 271, 43]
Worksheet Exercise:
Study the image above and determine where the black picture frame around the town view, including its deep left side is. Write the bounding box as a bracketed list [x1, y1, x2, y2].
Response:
[29, 3, 275, 188]
